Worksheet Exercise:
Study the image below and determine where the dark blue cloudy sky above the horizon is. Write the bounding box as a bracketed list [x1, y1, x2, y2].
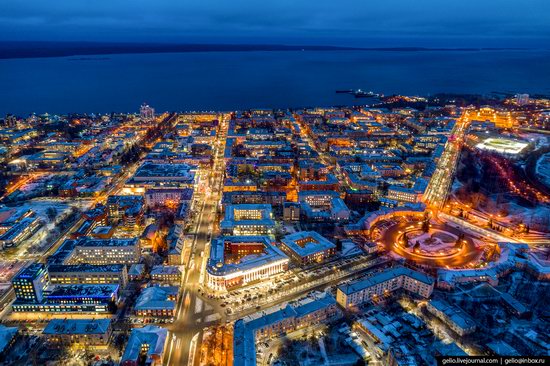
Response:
[0, 0, 550, 48]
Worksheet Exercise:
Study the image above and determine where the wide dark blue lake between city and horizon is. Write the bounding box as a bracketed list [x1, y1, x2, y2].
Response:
[0, 50, 550, 116]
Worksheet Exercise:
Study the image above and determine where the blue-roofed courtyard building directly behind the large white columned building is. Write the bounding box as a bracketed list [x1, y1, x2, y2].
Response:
[220, 204, 275, 236]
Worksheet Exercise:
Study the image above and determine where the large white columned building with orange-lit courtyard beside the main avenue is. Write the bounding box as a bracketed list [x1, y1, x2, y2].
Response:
[206, 236, 289, 291]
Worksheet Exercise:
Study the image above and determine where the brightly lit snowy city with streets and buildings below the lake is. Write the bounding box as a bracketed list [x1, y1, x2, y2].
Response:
[0, 94, 550, 365]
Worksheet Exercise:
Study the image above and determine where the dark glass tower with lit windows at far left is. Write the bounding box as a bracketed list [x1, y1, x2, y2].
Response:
[12, 263, 49, 303]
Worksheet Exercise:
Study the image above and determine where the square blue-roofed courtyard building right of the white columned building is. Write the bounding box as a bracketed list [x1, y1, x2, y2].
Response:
[281, 231, 336, 265]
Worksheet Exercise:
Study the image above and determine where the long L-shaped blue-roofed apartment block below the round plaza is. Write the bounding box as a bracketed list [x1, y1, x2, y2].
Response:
[336, 266, 435, 309]
